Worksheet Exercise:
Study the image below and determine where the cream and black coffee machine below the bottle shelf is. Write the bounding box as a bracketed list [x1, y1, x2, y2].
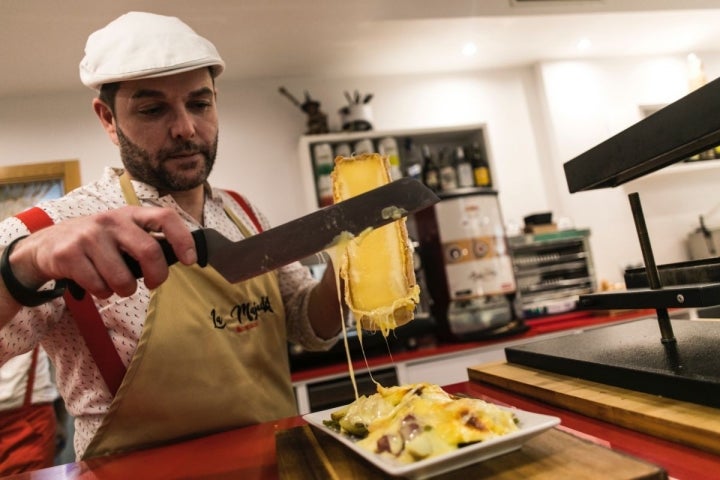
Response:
[415, 189, 526, 341]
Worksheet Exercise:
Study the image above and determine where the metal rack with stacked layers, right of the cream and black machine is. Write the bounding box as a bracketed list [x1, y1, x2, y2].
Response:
[508, 230, 597, 318]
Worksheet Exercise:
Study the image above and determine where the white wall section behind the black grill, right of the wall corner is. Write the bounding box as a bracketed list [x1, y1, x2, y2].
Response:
[538, 55, 720, 280]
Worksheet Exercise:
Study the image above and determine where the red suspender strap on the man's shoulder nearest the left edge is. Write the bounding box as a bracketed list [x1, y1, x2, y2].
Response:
[15, 207, 126, 396]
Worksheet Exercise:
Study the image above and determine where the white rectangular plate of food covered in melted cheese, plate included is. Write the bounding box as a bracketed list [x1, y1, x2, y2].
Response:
[303, 383, 560, 480]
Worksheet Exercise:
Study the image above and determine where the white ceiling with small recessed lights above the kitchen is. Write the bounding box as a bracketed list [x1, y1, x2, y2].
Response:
[0, 0, 720, 96]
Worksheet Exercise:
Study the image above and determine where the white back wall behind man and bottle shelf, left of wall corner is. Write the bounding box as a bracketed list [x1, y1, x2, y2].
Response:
[0, 69, 548, 235]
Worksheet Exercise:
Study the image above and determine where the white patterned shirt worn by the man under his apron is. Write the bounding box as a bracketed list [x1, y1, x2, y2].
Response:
[0, 168, 335, 458]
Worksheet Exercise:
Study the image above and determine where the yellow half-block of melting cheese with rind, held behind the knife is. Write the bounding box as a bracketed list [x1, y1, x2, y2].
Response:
[332, 153, 420, 336]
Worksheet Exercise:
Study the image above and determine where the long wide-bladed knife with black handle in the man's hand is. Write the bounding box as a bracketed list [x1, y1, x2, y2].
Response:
[68, 178, 440, 299]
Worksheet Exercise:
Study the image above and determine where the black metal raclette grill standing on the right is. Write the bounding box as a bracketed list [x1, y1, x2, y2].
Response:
[505, 74, 720, 407]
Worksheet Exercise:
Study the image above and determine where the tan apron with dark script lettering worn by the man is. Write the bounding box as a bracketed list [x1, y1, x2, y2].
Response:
[83, 176, 297, 458]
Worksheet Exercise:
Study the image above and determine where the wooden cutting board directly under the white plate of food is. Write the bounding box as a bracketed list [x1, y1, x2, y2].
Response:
[275, 425, 667, 480]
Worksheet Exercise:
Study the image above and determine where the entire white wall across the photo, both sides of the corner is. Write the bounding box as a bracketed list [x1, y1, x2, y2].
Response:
[0, 56, 720, 281]
